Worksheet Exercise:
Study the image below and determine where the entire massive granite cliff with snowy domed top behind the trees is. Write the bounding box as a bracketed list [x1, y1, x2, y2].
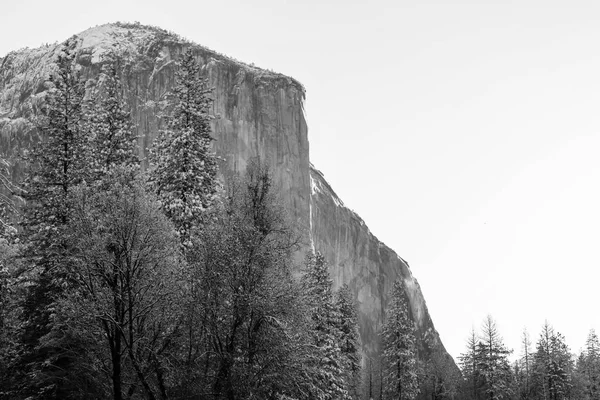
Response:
[0, 24, 450, 362]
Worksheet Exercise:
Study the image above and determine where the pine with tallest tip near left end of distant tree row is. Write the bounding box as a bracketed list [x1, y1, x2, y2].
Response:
[477, 315, 512, 400]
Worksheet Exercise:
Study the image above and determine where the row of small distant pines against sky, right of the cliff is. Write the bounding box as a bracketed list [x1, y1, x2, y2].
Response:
[459, 316, 600, 400]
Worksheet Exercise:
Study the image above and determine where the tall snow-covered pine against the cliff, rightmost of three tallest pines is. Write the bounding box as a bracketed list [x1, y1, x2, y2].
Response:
[149, 50, 218, 246]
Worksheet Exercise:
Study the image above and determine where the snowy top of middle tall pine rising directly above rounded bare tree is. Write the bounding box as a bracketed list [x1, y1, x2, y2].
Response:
[87, 53, 140, 184]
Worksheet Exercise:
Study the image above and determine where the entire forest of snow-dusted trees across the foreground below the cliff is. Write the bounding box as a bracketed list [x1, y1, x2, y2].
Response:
[0, 41, 600, 400]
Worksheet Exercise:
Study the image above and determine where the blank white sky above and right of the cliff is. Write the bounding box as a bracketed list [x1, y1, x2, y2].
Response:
[0, 0, 600, 357]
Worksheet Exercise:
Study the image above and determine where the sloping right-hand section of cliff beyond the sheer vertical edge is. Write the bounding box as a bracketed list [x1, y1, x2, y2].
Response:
[310, 164, 443, 354]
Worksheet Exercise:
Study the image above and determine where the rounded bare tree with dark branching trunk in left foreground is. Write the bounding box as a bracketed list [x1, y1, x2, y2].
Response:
[65, 182, 185, 400]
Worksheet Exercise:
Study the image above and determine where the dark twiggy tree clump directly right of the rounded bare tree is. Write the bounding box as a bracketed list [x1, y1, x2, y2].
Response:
[179, 162, 308, 399]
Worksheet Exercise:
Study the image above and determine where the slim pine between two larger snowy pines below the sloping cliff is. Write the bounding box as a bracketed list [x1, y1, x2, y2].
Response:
[335, 285, 361, 399]
